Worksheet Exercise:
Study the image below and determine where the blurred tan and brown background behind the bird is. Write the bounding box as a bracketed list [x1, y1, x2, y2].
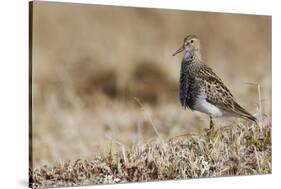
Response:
[32, 2, 272, 168]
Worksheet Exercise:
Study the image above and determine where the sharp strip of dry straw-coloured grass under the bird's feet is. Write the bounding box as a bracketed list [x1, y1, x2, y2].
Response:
[31, 118, 272, 188]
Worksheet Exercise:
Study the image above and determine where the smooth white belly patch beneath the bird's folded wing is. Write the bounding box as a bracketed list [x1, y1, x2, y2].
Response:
[193, 97, 225, 117]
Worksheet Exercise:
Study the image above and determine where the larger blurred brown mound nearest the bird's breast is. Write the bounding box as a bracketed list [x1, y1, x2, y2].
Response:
[124, 61, 177, 105]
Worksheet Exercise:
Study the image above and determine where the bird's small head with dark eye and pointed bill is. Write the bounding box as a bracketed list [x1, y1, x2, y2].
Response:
[173, 35, 200, 56]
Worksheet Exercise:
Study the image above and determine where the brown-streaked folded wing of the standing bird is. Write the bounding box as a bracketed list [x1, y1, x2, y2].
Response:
[197, 65, 256, 121]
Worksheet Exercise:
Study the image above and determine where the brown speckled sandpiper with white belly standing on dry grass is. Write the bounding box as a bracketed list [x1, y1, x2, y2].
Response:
[173, 35, 257, 129]
